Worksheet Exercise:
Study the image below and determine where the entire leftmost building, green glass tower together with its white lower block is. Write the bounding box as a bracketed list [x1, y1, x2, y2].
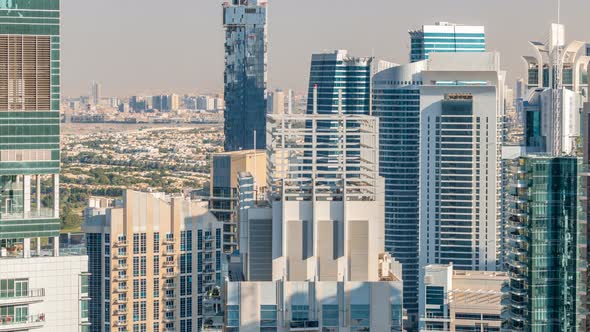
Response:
[0, 0, 88, 332]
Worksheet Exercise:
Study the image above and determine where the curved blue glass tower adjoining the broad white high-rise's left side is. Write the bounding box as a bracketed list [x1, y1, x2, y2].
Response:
[372, 61, 427, 327]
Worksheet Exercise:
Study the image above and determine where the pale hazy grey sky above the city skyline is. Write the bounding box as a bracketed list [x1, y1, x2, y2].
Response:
[62, 0, 590, 96]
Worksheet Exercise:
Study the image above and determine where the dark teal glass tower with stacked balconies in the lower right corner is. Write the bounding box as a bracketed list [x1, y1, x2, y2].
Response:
[503, 155, 587, 331]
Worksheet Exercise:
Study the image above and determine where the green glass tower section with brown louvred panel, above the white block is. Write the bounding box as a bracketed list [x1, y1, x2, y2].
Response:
[0, 0, 60, 241]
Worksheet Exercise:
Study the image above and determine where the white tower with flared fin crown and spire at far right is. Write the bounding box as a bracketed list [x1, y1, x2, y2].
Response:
[523, 24, 588, 155]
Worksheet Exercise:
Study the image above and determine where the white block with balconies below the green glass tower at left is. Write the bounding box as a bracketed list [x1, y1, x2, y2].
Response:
[0, 256, 88, 332]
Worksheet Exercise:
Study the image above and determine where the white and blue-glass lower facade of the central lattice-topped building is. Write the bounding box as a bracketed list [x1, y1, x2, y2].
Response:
[226, 281, 403, 332]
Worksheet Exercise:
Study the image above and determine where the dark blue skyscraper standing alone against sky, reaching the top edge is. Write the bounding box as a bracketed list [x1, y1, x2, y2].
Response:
[223, 0, 267, 152]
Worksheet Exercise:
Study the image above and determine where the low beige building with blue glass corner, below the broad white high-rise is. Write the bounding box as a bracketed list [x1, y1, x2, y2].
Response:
[420, 264, 509, 332]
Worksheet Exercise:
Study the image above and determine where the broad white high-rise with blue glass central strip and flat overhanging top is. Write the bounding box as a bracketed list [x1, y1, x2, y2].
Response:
[419, 53, 505, 271]
